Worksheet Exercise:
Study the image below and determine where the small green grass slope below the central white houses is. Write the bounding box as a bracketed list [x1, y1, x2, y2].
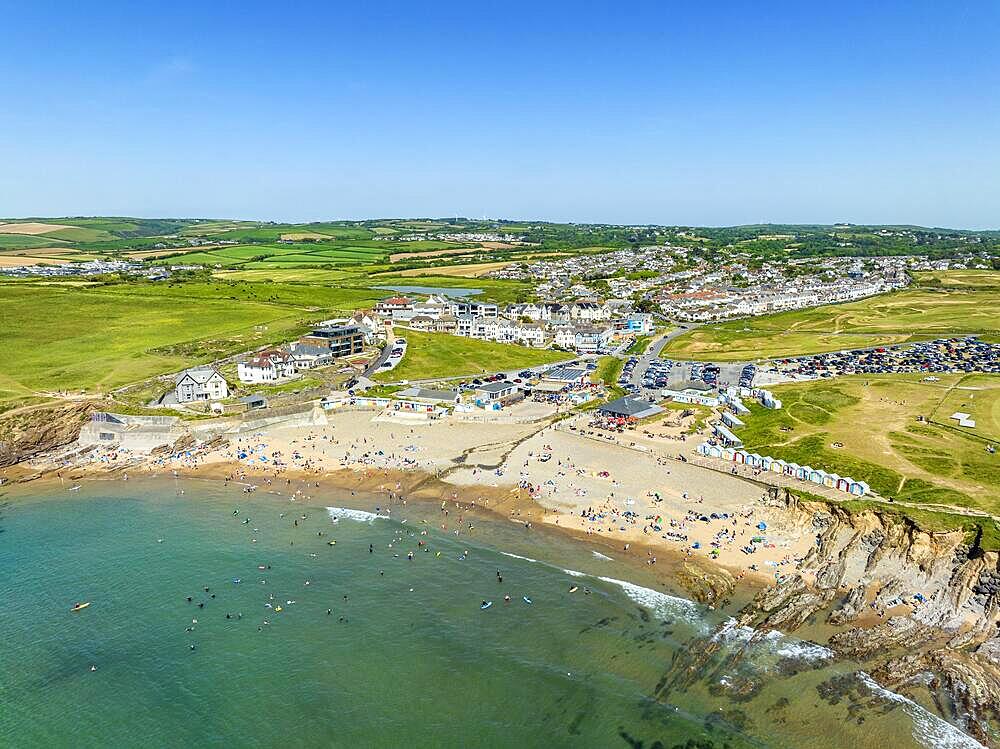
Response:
[374, 329, 569, 382]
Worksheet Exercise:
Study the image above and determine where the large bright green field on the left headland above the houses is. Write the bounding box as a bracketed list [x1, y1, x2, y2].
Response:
[0, 281, 381, 404]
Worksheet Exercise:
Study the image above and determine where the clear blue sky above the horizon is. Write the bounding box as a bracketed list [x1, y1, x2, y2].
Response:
[0, 0, 1000, 228]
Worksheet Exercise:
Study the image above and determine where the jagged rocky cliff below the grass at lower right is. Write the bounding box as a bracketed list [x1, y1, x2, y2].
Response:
[739, 490, 1000, 745]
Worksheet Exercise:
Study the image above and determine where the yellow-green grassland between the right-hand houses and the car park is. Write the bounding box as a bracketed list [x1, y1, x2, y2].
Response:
[664, 271, 1000, 361]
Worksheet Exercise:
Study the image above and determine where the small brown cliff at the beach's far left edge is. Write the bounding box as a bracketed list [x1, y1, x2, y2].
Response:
[0, 402, 96, 468]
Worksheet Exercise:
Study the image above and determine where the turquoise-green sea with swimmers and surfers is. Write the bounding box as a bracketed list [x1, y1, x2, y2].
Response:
[0, 479, 977, 749]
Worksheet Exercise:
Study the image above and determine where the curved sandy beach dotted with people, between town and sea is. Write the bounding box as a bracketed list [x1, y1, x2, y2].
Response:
[27, 404, 815, 582]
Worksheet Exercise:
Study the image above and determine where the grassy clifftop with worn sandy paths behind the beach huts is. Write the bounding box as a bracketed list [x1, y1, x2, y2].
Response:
[737, 374, 1000, 514]
